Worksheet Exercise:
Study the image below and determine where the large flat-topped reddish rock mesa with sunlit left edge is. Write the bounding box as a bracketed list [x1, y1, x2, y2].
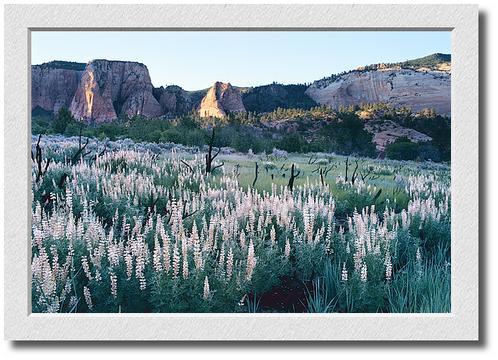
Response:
[70, 60, 162, 123]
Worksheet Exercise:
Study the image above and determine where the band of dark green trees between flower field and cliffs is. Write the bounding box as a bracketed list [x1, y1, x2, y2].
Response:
[32, 104, 451, 161]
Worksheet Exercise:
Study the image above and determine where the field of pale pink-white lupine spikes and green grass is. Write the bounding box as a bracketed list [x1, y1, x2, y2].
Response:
[31, 136, 451, 313]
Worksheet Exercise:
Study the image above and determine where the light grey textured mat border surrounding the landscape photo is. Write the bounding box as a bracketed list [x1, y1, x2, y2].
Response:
[4, 5, 479, 341]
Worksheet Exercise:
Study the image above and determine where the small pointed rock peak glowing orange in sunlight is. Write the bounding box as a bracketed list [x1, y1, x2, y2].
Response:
[199, 82, 246, 118]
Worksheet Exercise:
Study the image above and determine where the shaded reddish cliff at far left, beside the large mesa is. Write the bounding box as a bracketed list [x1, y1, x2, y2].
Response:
[31, 61, 85, 114]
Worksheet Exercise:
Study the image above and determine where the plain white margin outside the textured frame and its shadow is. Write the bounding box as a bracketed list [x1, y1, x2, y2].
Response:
[0, 0, 498, 360]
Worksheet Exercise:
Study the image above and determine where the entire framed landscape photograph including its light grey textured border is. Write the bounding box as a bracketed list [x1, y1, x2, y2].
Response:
[5, 5, 479, 341]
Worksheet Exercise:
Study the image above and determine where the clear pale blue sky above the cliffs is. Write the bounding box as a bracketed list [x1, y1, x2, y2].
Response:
[31, 31, 451, 90]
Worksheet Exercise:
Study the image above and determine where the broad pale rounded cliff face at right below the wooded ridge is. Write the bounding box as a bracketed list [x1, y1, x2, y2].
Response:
[306, 65, 451, 115]
